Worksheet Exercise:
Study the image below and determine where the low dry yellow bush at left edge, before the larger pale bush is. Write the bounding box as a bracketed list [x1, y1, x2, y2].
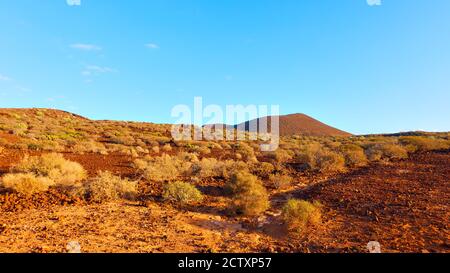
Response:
[0, 173, 54, 195]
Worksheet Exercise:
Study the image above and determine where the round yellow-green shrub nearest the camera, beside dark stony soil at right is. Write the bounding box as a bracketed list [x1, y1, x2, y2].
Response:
[283, 199, 322, 232]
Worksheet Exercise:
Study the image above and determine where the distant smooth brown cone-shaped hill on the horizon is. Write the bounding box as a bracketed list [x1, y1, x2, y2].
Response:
[206, 114, 352, 136]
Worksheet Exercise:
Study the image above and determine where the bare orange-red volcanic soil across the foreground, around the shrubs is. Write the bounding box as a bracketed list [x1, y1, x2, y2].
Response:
[0, 150, 450, 253]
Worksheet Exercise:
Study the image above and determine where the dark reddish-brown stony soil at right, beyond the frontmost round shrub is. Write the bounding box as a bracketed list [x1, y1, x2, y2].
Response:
[278, 151, 450, 253]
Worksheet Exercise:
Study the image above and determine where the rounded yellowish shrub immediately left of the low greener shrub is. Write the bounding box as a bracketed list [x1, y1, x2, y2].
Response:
[85, 172, 138, 203]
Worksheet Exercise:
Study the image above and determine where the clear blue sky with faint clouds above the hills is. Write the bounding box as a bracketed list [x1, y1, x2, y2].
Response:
[0, 0, 450, 134]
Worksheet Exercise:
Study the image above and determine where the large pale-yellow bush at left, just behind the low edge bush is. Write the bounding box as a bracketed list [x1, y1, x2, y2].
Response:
[12, 153, 87, 187]
